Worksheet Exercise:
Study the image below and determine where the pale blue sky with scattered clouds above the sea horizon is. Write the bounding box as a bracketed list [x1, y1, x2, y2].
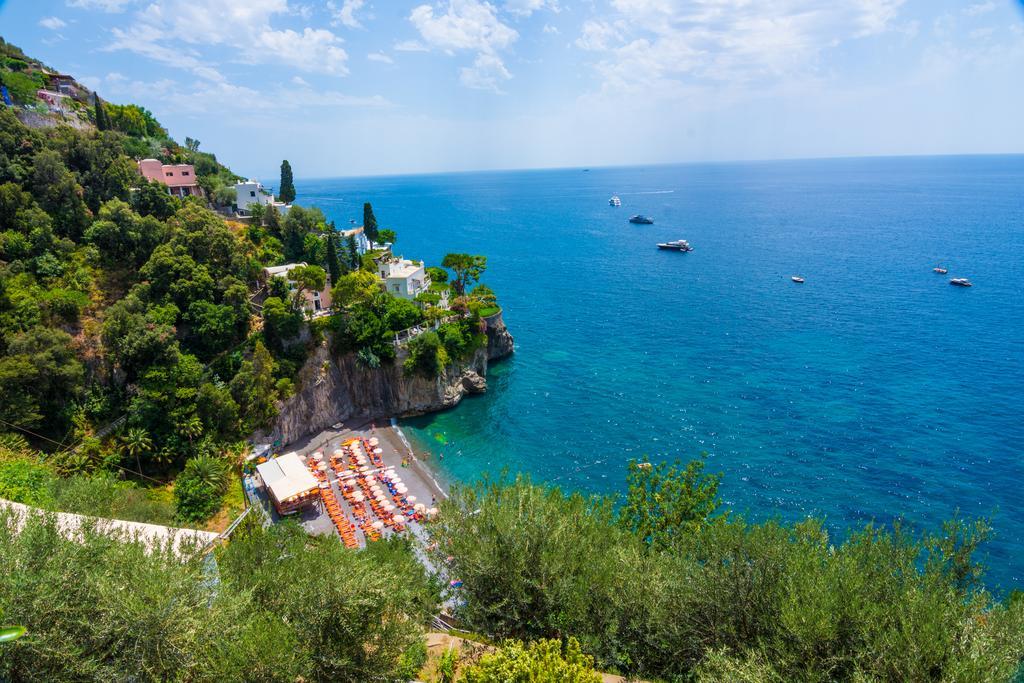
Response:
[0, 0, 1024, 178]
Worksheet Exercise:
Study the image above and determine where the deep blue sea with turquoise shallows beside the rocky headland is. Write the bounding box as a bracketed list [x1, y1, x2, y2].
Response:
[298, 156, 1024, 590]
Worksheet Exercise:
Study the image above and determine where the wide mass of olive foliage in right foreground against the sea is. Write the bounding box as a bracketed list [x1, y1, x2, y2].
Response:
[431, 465, 1024, 683]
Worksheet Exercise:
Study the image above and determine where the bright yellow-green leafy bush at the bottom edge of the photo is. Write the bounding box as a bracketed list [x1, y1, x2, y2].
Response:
[461, 638, 601, 683]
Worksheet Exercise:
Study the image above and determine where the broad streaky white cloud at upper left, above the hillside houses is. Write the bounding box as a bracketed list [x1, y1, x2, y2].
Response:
[106, 0, 348, 81]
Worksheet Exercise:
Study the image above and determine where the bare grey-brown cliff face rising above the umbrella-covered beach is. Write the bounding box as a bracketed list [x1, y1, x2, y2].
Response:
[252, 312, 514, 443]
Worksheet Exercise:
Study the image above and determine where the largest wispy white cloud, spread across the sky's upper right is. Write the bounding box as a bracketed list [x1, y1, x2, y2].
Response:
[575, 0, 904, 90]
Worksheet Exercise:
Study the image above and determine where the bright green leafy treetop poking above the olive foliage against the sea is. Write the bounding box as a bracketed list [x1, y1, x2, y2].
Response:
[620, 459, 722, 549]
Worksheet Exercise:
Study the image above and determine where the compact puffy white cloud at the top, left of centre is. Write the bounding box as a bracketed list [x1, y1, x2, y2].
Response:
[409, 0, 519, 54]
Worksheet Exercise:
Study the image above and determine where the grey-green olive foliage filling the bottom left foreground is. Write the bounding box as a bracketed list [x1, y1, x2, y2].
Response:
[0, 511, 436, 683]
